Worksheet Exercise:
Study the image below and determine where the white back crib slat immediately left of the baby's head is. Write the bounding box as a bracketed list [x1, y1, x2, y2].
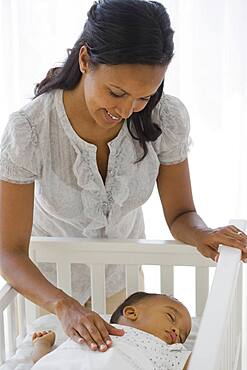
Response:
[91, 265, 106, 313]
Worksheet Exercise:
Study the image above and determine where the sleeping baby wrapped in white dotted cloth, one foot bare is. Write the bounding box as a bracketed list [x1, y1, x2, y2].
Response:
[32, 292, 191, 370]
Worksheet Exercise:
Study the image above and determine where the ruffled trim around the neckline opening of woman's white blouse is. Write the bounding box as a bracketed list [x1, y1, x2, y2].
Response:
[70, 132, 137, 237]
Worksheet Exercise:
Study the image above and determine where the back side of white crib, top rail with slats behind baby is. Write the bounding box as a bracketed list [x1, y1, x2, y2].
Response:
[27, 237, 216, 319]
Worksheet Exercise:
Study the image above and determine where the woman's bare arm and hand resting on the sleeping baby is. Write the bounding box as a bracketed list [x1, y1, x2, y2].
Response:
[0, 181, 124, 351]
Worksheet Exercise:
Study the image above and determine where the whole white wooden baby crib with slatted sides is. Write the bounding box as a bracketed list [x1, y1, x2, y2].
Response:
[0, 222, 245, 370]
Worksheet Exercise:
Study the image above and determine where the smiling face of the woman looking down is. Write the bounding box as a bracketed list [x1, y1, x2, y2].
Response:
[80, 47, 166, 130]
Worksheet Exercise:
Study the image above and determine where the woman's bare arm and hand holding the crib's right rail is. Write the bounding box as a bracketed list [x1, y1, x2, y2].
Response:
[157, 160, 247, 260]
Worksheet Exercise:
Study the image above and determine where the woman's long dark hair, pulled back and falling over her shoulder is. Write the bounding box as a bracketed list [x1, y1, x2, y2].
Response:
[35, 0, 174, 160]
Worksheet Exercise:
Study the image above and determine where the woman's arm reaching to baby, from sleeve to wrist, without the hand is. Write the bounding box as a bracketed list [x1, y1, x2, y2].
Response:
[0, 181, 68, 313]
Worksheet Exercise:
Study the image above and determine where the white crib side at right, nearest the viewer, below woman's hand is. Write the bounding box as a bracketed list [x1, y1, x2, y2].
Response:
[189, 246, 242, 370]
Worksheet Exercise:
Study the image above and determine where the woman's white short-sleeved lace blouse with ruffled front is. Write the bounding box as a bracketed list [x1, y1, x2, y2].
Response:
[0, 89, 190, 303]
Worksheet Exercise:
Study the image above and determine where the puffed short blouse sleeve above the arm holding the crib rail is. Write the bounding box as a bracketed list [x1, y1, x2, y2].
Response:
[152, 94, 191, 164]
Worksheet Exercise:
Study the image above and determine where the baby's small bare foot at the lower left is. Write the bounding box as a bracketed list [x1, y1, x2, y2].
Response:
[32, 330, 55, 363]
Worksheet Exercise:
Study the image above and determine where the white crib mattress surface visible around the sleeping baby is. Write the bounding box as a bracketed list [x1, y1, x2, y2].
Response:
[0, 314, 200, 370]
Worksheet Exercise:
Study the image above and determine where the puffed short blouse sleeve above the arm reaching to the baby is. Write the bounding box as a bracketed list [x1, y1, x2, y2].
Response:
[0, 111, 41, 184]
